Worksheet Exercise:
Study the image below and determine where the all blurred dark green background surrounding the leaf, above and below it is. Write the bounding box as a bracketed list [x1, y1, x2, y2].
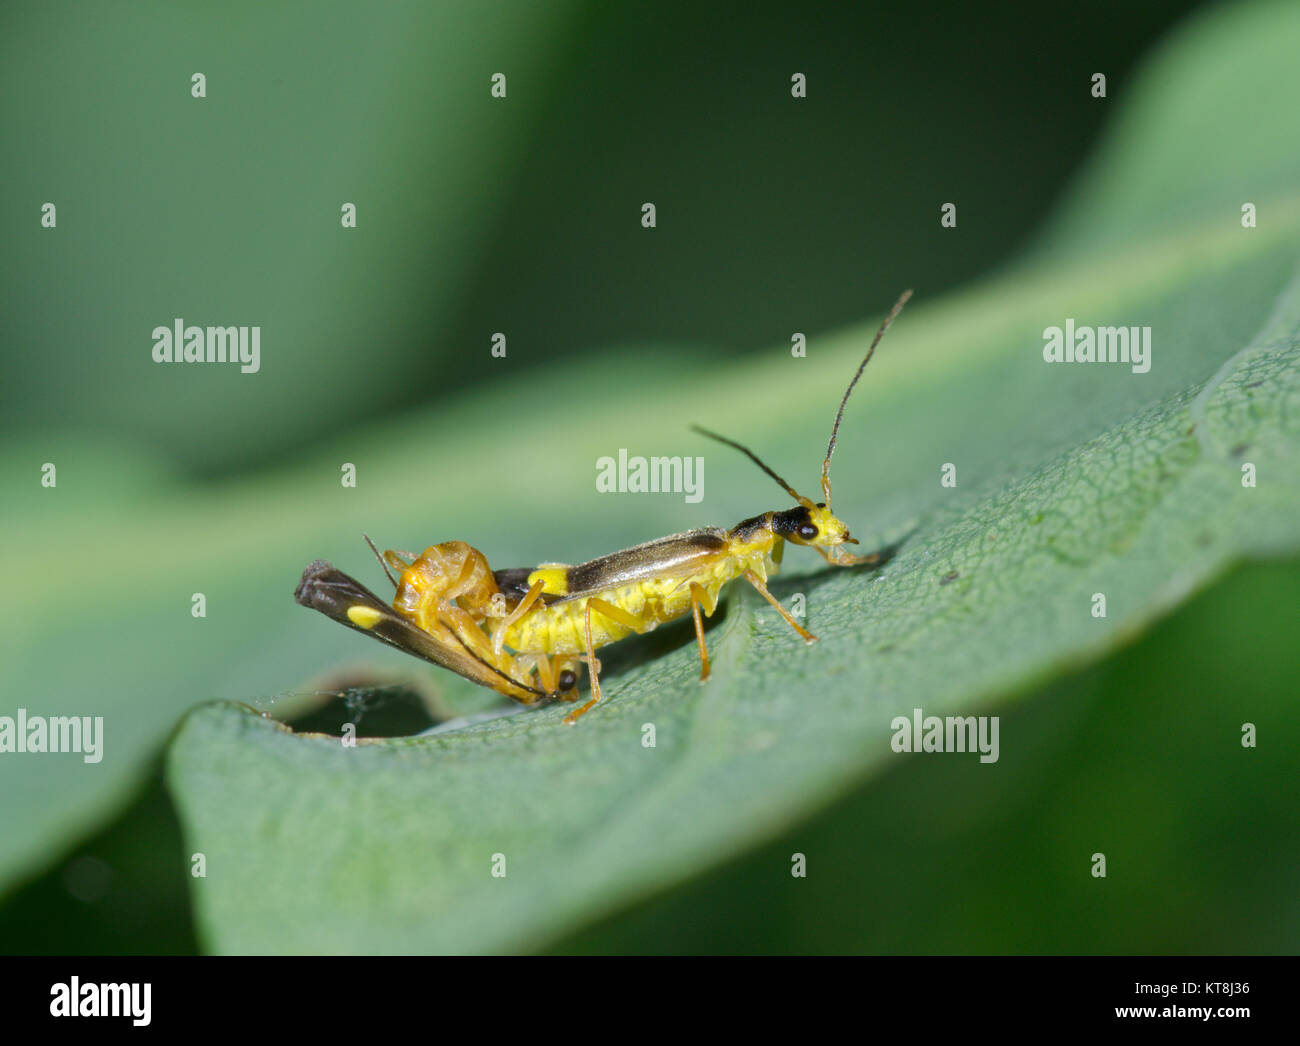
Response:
[10, 3, 1300, 952]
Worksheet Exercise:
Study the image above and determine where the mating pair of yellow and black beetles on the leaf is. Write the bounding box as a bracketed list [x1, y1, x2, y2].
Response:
[294, 291, 911, 724]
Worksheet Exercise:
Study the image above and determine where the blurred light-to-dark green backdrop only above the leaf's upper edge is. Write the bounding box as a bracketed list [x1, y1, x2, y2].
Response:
[0, 0, 1211, 477]
